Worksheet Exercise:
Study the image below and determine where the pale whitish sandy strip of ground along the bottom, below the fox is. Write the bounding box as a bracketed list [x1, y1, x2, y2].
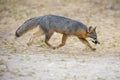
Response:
[0, 52, 120, 80]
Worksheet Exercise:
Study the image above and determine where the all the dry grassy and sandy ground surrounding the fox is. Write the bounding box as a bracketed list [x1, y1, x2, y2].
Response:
[0, 0, 120, 80]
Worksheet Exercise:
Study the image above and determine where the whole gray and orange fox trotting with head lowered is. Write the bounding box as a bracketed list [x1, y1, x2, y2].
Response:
[15, 15, 100, 50]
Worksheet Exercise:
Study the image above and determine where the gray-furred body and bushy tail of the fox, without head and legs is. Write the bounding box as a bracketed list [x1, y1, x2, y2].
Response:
[16, 15, 88, 37]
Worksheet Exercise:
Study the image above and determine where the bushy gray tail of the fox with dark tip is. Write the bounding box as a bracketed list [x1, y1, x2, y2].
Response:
[15, 18, 39, 37]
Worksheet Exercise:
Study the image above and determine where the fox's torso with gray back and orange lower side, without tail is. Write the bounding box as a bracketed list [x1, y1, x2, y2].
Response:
[40, 15, 88, 36]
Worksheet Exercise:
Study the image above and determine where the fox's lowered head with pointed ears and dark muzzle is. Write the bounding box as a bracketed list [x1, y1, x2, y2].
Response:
[88, 26, 100, 44]
